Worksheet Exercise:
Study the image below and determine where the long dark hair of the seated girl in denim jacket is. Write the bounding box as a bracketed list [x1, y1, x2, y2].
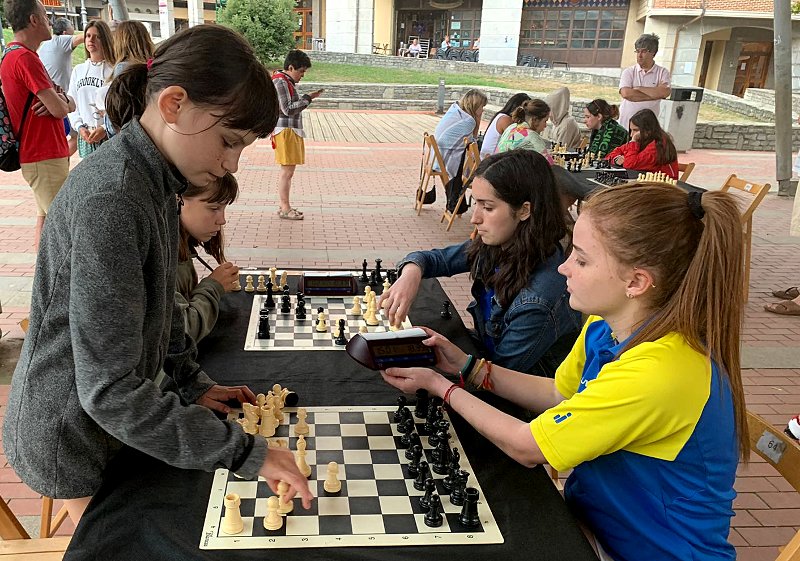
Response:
[467, 150, 567, 306]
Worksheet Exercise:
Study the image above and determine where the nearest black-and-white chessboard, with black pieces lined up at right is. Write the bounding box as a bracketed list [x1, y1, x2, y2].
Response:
[200, 407, 504, 549]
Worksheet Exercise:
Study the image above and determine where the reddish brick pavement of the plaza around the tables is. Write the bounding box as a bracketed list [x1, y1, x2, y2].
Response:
[0, 110, 800, 561]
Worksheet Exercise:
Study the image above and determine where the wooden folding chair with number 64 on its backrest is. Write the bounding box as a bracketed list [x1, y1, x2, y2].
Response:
[747, 411, 800, 561]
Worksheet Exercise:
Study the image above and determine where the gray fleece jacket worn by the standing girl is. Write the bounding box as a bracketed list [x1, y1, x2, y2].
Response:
[3, 120, 267, 498]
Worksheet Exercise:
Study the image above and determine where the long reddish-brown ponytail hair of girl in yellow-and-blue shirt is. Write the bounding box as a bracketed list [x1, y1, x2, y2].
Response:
[581, 182, 750, 461]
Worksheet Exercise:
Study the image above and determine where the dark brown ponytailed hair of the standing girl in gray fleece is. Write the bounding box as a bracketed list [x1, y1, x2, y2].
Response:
[106, 25, 278, 138]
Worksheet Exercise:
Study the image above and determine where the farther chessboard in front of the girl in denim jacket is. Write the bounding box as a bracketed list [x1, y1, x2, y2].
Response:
[244, 294, 412, 351]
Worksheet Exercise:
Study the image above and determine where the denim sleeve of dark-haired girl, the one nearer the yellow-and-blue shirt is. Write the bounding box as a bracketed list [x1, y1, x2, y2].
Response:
[494, 295, 558, 373]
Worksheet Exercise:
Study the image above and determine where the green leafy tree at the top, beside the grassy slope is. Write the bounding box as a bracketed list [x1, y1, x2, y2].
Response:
[218, 0, 297, 63]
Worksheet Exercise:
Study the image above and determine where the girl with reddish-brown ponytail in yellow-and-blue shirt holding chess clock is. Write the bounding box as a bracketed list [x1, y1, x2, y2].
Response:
[383, 183, 750, 561]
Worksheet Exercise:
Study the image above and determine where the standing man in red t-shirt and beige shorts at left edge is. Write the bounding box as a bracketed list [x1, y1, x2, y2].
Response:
[0, 0, 75, 248]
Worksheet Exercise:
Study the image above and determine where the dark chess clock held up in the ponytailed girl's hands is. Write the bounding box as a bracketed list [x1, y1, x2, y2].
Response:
[346, 327, 436, 370]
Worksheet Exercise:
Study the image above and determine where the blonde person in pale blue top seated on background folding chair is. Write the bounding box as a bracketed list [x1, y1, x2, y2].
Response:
[433, 89, 488, 179]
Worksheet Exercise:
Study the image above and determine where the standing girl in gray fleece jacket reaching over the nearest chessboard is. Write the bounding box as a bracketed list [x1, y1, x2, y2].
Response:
[3, 25, 311, 523]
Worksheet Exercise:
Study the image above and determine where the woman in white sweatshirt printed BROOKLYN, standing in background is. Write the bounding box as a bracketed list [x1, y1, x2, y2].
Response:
[69, 20, 114, 158]
